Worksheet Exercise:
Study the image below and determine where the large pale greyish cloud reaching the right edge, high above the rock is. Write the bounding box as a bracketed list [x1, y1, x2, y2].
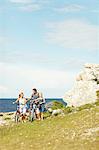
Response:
[45, 20, 99, 50]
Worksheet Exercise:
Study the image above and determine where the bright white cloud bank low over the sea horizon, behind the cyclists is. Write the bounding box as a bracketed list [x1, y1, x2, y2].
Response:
[0, 63, 74, 97]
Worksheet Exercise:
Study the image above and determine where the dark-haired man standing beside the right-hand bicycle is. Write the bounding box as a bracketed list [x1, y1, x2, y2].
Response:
[30, 88, 45, 120]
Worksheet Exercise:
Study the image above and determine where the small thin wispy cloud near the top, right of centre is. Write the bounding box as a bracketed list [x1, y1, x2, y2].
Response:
[54, 4, 84, 12]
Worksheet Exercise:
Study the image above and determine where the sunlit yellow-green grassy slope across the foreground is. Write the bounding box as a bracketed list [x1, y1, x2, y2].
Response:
[0, 103, 99, 150]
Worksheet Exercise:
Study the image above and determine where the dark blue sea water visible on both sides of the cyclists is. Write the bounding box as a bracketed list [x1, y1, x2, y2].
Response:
[0, 98, 66, 112]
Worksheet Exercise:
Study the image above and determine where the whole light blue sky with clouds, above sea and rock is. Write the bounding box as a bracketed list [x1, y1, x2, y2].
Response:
[0, 0, 99, 98]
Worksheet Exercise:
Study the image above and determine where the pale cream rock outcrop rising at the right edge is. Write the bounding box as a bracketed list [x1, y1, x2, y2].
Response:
[63, 64, 99, 106]
